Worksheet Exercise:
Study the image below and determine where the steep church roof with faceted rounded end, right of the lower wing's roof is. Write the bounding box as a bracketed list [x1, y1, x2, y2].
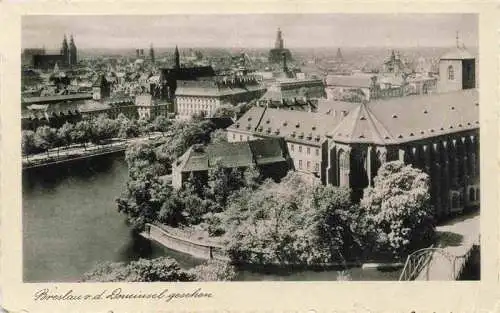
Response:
[331, 89, 479, 144]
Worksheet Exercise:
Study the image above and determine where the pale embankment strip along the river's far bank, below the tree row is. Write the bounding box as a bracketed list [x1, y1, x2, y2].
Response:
[22, 132, 162, 169]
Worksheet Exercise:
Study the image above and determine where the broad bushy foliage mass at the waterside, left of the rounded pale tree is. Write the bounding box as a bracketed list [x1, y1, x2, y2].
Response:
[221, 172, 353, 264]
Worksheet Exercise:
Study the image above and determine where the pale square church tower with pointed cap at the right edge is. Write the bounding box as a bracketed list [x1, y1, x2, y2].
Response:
[438, 34, 476, 92]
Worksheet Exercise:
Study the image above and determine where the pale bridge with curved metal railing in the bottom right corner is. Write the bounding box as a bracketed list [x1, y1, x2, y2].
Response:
[400, 212, 480, 281]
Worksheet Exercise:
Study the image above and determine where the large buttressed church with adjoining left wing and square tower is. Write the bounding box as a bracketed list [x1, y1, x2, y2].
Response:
[227, 47, 480, 218]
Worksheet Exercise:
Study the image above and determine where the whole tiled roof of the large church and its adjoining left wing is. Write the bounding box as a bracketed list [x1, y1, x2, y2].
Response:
[232, 89, 479, 145]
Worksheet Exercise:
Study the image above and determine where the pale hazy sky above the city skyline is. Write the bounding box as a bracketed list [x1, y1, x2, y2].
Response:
[22, 14, 478, 50]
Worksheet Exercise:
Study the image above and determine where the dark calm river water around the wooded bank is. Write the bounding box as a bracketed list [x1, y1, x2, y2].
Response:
[23, 154, 399, 282]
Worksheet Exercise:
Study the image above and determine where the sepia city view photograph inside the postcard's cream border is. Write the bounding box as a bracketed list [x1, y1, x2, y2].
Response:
[20, 13, 480, 283]
